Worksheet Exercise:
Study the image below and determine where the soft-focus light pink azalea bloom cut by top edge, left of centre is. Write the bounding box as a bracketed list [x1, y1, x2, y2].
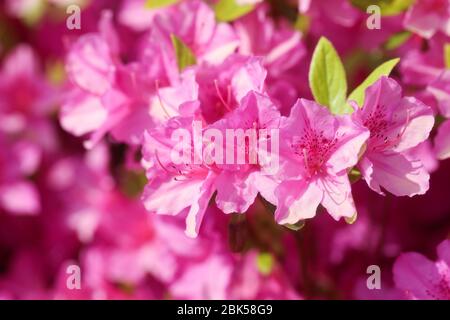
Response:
[119, 0, 239, 68]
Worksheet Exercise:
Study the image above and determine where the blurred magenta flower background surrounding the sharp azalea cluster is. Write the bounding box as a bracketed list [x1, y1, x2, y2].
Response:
[0, 0, 450, 299]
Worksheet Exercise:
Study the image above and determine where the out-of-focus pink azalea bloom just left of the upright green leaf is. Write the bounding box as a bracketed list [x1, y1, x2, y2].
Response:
[233, 5, 309, 114]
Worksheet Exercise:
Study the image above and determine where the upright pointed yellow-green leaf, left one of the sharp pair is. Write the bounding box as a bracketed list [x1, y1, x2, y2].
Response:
[309, 37, 347, 114]
